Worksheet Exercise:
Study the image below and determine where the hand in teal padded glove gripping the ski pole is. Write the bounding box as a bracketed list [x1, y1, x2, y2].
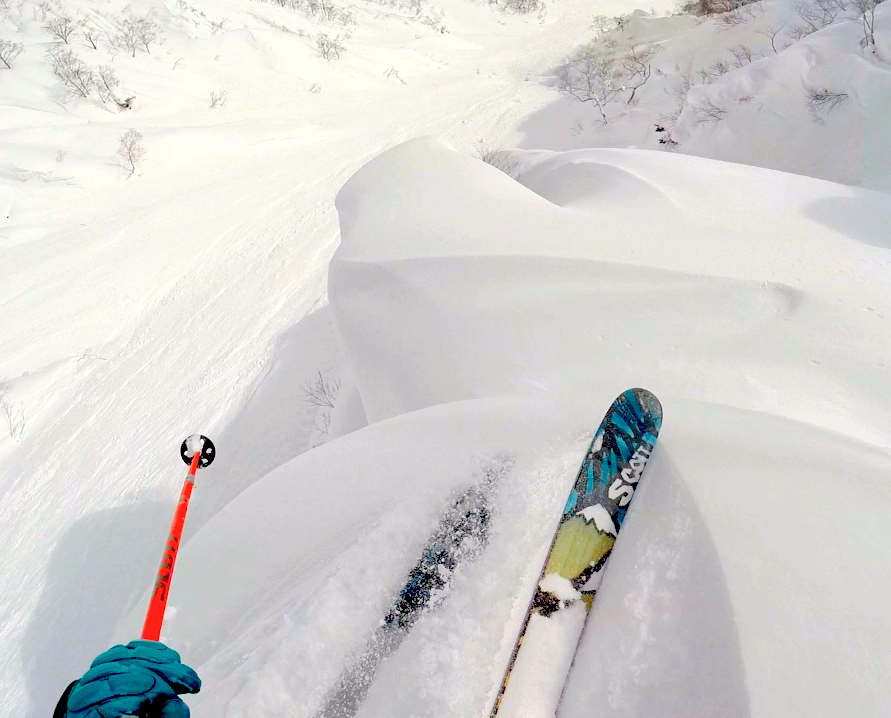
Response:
[64, 641, 201, 718]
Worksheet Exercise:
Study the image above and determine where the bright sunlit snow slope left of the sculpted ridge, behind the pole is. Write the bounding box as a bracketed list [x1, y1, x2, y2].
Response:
[0, 0, 631, 716]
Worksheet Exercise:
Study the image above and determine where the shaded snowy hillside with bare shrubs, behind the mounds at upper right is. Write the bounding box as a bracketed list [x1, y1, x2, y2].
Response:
[513, 0, 891, 191]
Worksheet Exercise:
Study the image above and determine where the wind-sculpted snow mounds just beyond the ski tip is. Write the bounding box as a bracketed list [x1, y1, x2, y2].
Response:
[330, 140, 891, 443]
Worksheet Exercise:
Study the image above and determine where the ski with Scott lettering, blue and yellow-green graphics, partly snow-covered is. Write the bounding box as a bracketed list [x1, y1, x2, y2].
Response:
[490, 389, 662, 718]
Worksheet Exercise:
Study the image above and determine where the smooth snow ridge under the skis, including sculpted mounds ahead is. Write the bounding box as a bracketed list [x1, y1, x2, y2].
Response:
[119, 139, 891, 718]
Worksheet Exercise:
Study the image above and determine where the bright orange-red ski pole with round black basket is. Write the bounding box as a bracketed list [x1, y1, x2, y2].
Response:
[142, 435, 216, 641]
